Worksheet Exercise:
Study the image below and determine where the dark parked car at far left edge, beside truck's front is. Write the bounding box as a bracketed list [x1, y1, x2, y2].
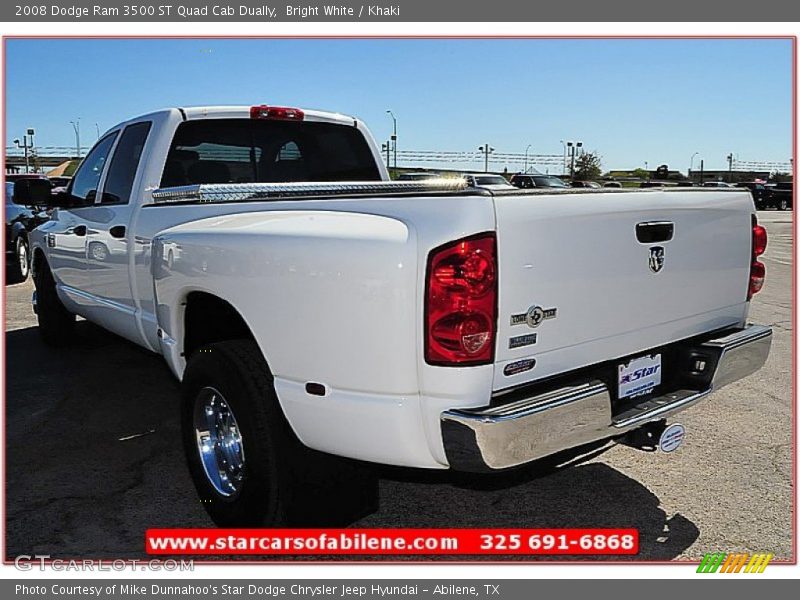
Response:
[4, 177, 49, 283]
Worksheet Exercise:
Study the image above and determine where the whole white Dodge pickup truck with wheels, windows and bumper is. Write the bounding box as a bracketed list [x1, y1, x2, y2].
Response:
[25, 106, 772, 525]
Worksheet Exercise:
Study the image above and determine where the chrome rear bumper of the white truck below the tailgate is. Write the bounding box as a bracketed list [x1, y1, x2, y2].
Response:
[441, 325, 772, 471]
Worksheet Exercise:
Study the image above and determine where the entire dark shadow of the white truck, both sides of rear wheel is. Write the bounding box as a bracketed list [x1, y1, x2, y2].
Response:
[6, 322, 699, 561]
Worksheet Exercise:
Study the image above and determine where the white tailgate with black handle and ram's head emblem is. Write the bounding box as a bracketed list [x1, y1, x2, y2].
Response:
[494, 189, 753, 390]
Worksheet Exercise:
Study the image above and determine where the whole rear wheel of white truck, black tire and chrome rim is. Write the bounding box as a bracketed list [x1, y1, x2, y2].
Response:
[181, 340, 300, 527]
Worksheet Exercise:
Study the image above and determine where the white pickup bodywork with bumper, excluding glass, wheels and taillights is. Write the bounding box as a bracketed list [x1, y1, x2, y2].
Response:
[31, 107, 771, 496]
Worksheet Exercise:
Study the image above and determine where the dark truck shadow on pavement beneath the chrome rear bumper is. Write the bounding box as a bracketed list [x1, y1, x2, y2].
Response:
[372, 460, 700, 561]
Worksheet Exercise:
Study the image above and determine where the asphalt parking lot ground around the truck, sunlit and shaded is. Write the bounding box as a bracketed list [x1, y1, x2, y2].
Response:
[5, 212, 793, 560]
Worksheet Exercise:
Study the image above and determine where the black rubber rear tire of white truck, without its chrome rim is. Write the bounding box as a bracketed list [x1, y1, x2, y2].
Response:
[181, 340, 296, 527]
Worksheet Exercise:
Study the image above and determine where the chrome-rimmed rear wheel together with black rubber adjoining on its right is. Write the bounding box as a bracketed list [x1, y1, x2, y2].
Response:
[181, 340, 378, 527]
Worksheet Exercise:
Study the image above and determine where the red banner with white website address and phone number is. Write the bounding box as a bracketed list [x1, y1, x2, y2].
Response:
[145, 529, 639, 555]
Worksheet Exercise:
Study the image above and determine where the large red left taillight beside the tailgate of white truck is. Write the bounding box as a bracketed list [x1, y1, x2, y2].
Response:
[425, 233, 497, 366]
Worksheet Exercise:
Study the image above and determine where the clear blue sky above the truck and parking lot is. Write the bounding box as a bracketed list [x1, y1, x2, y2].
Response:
[5, 39, 792, 172]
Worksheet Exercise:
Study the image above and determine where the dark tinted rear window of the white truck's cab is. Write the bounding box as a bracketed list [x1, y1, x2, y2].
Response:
[161, 119, 380, 187]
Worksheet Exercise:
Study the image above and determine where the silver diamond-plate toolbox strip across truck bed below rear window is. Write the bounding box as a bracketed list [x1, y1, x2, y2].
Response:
[153, 177, 467, 204]
